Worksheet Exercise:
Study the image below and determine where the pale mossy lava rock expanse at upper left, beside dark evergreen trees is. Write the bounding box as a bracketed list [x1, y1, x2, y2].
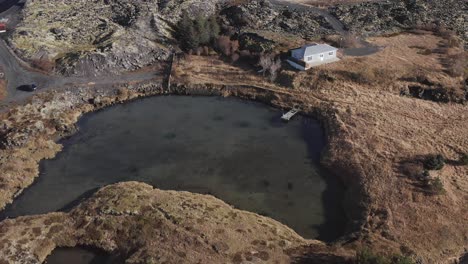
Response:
[10, 0, 221, 76]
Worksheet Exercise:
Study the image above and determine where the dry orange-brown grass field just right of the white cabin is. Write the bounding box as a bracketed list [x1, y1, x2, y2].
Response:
[320, 32, 462, 93]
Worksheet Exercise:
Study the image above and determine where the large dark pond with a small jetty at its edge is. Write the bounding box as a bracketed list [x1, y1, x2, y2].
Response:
[0, 96, 343, 240]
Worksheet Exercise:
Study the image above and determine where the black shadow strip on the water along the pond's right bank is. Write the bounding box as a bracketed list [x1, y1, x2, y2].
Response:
[301, 118, 346, 242]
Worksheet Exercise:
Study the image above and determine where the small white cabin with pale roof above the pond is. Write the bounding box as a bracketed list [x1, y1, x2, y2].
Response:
[287, 44, 340, 71]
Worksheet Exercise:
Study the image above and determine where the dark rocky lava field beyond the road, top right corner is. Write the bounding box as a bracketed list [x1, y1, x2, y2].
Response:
[330, 0, 468, 42]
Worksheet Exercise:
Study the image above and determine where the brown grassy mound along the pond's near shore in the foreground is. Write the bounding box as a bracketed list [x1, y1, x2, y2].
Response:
[0, 182, 345, 264]
